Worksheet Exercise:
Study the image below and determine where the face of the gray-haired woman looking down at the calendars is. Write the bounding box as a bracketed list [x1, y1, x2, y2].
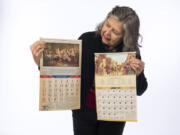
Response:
[101, 17, 123, 48]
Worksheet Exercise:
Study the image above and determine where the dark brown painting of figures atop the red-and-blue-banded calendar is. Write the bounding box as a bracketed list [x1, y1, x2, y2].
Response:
[43, 43, 79, 67]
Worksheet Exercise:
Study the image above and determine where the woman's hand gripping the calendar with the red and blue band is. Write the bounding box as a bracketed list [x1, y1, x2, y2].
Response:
[30, 41, 46, 66]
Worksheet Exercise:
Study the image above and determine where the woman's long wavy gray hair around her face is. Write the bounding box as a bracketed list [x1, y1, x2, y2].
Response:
[96, 6, 140, 54]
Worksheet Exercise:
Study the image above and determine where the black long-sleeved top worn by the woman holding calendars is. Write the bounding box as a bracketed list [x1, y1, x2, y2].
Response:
[74, 32, 147, 119]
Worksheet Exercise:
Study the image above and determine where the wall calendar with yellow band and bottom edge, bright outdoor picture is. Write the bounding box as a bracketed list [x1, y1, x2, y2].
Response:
[95, 52, 137, 121]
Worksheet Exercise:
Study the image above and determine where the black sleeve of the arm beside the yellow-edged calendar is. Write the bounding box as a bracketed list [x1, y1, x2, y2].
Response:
[136, 52, 148, 96]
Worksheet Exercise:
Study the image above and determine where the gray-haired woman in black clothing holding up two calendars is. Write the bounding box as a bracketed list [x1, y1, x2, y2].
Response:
[31, 6, 147, 135]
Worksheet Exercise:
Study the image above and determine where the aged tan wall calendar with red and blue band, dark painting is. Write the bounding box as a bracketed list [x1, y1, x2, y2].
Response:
[39, 38, 82, 111]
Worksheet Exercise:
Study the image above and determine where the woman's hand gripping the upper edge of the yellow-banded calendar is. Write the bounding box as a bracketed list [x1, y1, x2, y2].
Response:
[130, 58, 144, 76]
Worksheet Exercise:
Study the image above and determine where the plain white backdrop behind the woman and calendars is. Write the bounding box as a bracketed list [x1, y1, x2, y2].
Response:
[0, 0, 180, 135]
